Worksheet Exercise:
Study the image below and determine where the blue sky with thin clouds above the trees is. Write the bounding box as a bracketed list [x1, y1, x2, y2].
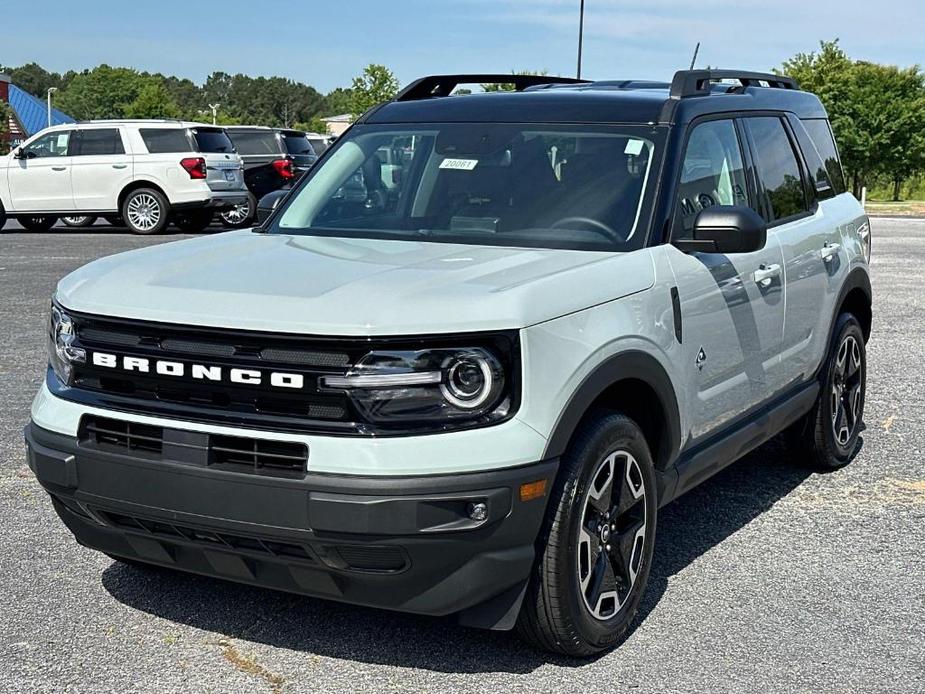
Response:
[0, 0, 925, 91]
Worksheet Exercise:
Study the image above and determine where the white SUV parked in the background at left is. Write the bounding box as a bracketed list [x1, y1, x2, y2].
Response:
[0, 120, 247, 234]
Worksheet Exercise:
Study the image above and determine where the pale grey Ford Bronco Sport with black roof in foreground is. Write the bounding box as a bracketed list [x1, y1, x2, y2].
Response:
[26, 71, 871, 656]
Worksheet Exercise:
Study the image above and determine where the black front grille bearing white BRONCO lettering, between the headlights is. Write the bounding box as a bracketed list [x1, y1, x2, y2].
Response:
[58, 315, 369, 433]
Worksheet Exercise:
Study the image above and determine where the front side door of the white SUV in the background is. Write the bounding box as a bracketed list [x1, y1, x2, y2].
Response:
[8, 130, 74, 212]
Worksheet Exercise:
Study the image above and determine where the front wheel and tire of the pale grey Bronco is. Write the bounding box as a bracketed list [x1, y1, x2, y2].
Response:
[517, 413, 658, 657]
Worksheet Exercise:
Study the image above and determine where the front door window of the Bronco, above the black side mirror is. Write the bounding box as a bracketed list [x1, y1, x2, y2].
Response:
[674, 120, 748, 238]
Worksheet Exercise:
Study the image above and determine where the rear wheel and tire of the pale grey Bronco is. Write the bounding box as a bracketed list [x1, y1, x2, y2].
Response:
[788, 313, 867, 470]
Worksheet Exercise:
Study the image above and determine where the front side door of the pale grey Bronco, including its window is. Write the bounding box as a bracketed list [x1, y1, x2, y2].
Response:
[668, 118, 784, 442]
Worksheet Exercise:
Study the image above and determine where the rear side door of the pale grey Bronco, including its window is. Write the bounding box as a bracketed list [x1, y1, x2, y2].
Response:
[742, 116, 837, 388]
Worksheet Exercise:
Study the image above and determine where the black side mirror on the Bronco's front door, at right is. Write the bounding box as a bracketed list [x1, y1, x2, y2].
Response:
[672, 205, 768, 254]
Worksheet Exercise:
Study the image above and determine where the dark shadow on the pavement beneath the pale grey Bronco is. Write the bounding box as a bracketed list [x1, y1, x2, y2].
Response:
[102, 437, 810, 674]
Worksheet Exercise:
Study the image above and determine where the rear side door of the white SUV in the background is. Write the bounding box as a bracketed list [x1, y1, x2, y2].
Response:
[71, 127, 134, 212]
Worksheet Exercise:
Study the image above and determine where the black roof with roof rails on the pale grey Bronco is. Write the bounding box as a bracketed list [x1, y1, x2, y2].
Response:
[361, 70, 826, 124]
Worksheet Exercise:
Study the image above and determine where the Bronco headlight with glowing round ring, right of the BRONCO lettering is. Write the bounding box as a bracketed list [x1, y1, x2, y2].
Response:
[321, 347, 511, 425]
